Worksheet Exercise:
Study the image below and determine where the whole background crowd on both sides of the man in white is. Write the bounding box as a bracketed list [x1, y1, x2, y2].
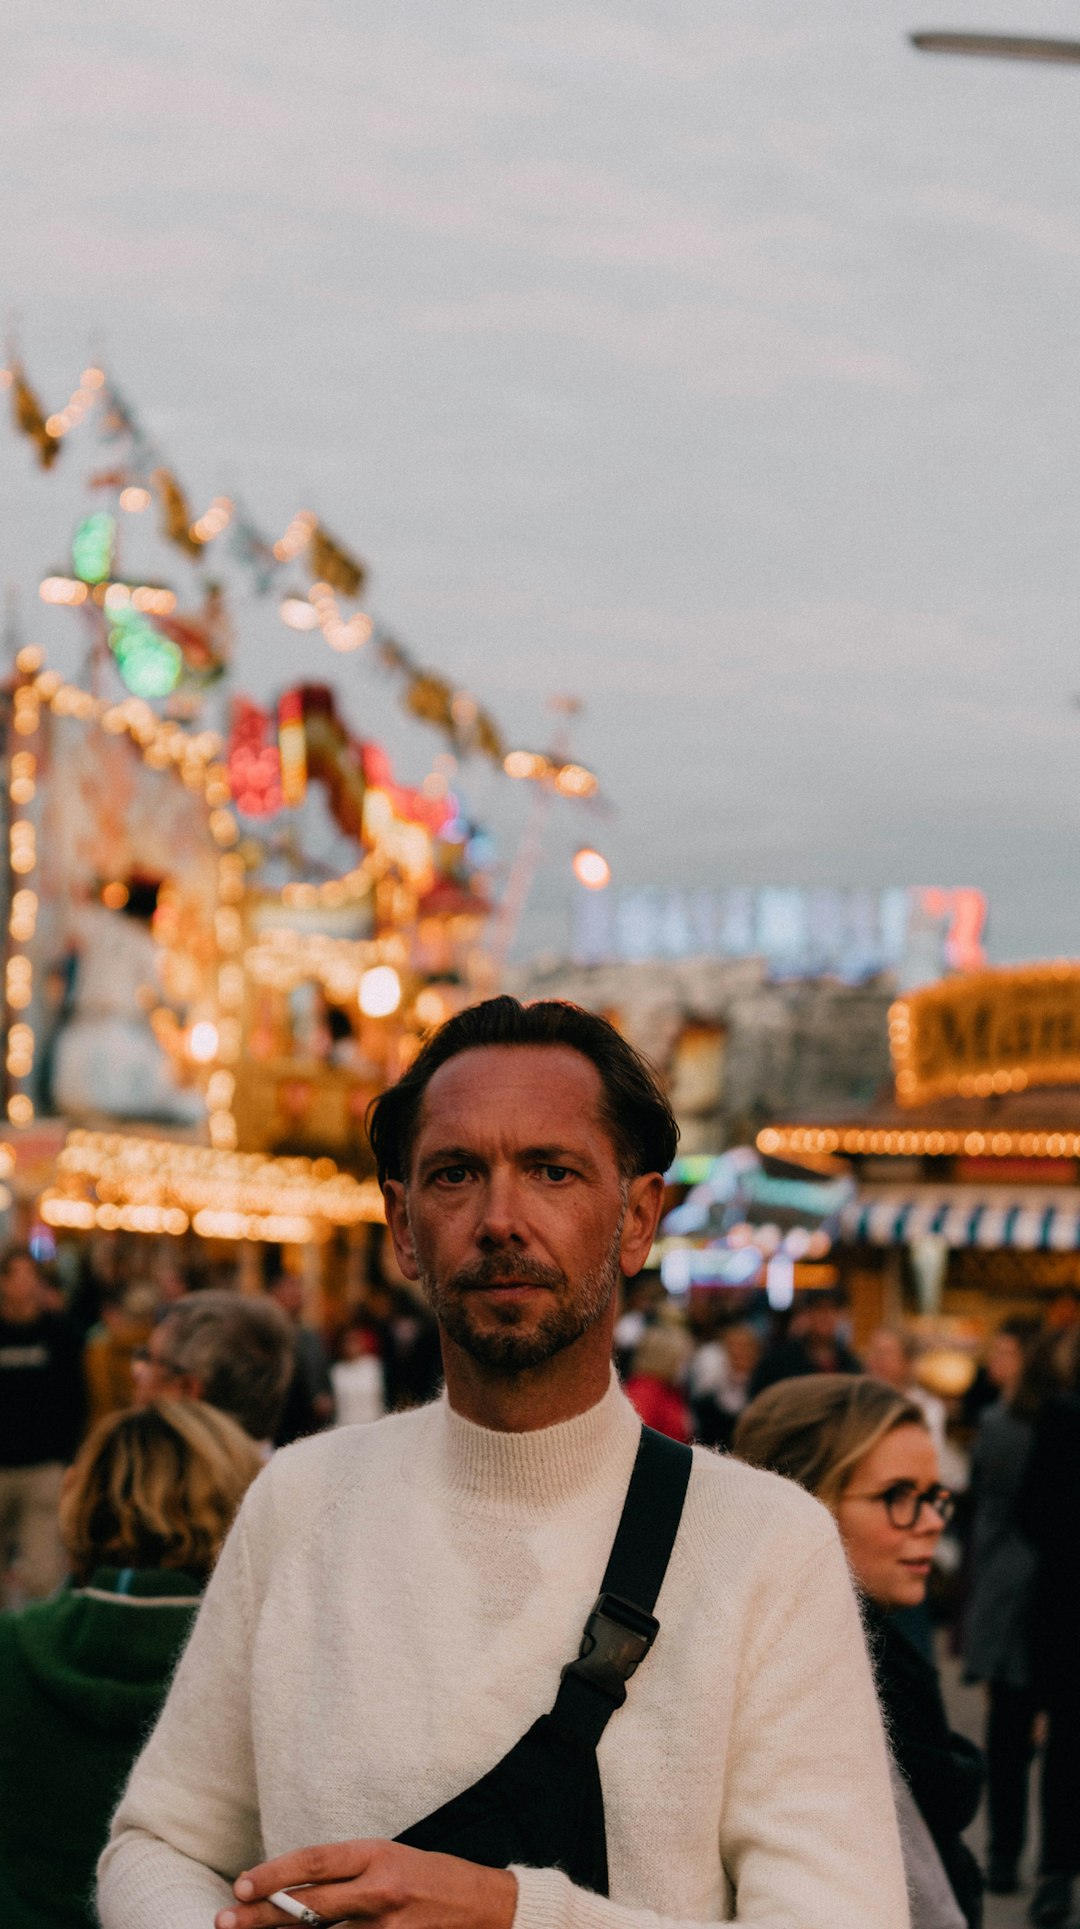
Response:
[0, 1126, 1080, 1929]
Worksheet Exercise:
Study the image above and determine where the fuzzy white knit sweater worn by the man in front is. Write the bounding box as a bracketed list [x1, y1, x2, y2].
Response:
[98, 1383, 908, 1929]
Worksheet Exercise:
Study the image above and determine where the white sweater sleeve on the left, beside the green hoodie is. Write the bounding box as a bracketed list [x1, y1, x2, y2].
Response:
[98, 1510, 260, 1929]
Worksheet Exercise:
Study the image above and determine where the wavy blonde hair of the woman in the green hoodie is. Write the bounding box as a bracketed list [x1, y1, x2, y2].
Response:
[60, 1400, 262, 1582]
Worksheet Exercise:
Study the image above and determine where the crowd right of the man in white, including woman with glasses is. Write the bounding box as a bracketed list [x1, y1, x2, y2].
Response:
[615, 1283, 1080, 1925]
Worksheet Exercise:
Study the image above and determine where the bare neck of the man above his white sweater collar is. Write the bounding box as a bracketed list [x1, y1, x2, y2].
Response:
[442, 1333, 611, 1433]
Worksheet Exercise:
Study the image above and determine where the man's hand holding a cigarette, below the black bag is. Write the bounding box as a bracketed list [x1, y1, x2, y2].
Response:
[214, 1842, 517, 1929]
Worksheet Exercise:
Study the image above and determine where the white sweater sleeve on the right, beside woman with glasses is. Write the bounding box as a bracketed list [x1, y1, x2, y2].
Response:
[513, 1528, 910, 1929]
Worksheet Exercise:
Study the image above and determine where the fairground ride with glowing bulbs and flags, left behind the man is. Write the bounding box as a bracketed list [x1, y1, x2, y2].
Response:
[0, 359, 598, 1304]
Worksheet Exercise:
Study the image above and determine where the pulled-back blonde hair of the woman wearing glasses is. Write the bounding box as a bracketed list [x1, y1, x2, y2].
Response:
[731, 1373, 926, 1512]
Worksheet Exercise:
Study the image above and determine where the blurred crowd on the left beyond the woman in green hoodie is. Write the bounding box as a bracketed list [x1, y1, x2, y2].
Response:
[0, 1248, 442, 1607]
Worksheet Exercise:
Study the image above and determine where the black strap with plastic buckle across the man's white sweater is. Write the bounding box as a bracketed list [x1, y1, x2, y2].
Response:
[552, 1427, 694, 1750]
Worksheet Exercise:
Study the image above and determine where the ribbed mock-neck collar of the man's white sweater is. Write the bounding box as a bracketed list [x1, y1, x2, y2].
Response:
[420, 1372, 640, 1514]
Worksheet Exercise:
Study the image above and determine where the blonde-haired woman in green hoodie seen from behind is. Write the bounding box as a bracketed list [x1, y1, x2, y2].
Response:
[0, 1400, 262, 1929]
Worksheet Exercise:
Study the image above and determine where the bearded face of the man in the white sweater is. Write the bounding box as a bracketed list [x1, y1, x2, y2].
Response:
[386, 1046, 662, 1373]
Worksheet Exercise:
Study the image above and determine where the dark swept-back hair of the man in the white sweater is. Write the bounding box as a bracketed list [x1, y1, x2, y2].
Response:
[366, 997, 679, 1184]
